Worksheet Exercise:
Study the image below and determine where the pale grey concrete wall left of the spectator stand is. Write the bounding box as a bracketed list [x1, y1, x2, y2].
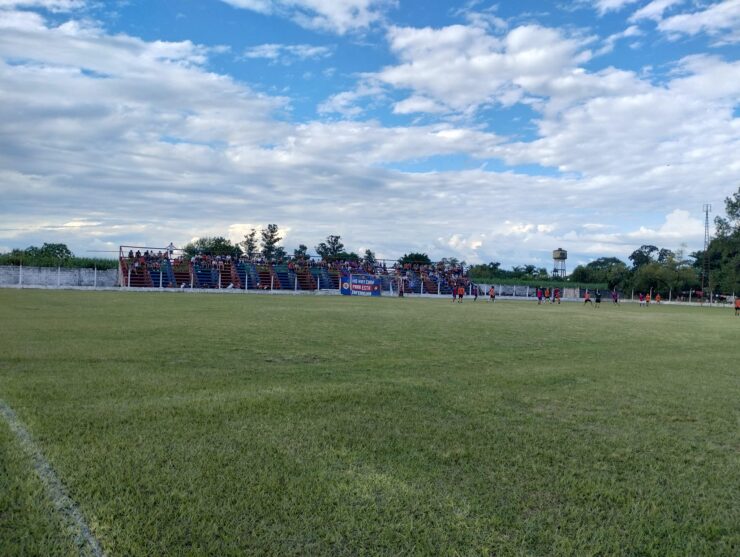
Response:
[0, 265, 118, 287]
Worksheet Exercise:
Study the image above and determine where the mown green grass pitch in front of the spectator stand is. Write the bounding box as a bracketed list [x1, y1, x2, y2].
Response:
[0, 290, 740, 556]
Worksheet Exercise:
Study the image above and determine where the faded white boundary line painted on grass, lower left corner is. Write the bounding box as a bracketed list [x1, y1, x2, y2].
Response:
[0, 399, 105, 557]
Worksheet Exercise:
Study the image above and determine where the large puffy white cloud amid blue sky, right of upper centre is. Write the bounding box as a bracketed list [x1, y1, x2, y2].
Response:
[373, 25, 590, 113]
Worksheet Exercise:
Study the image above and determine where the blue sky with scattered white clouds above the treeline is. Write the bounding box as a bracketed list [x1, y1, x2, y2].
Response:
[0, 0, 740, 268]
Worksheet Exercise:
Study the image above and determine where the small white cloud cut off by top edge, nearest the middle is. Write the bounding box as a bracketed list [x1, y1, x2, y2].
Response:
[218, 0, 397, 35]
